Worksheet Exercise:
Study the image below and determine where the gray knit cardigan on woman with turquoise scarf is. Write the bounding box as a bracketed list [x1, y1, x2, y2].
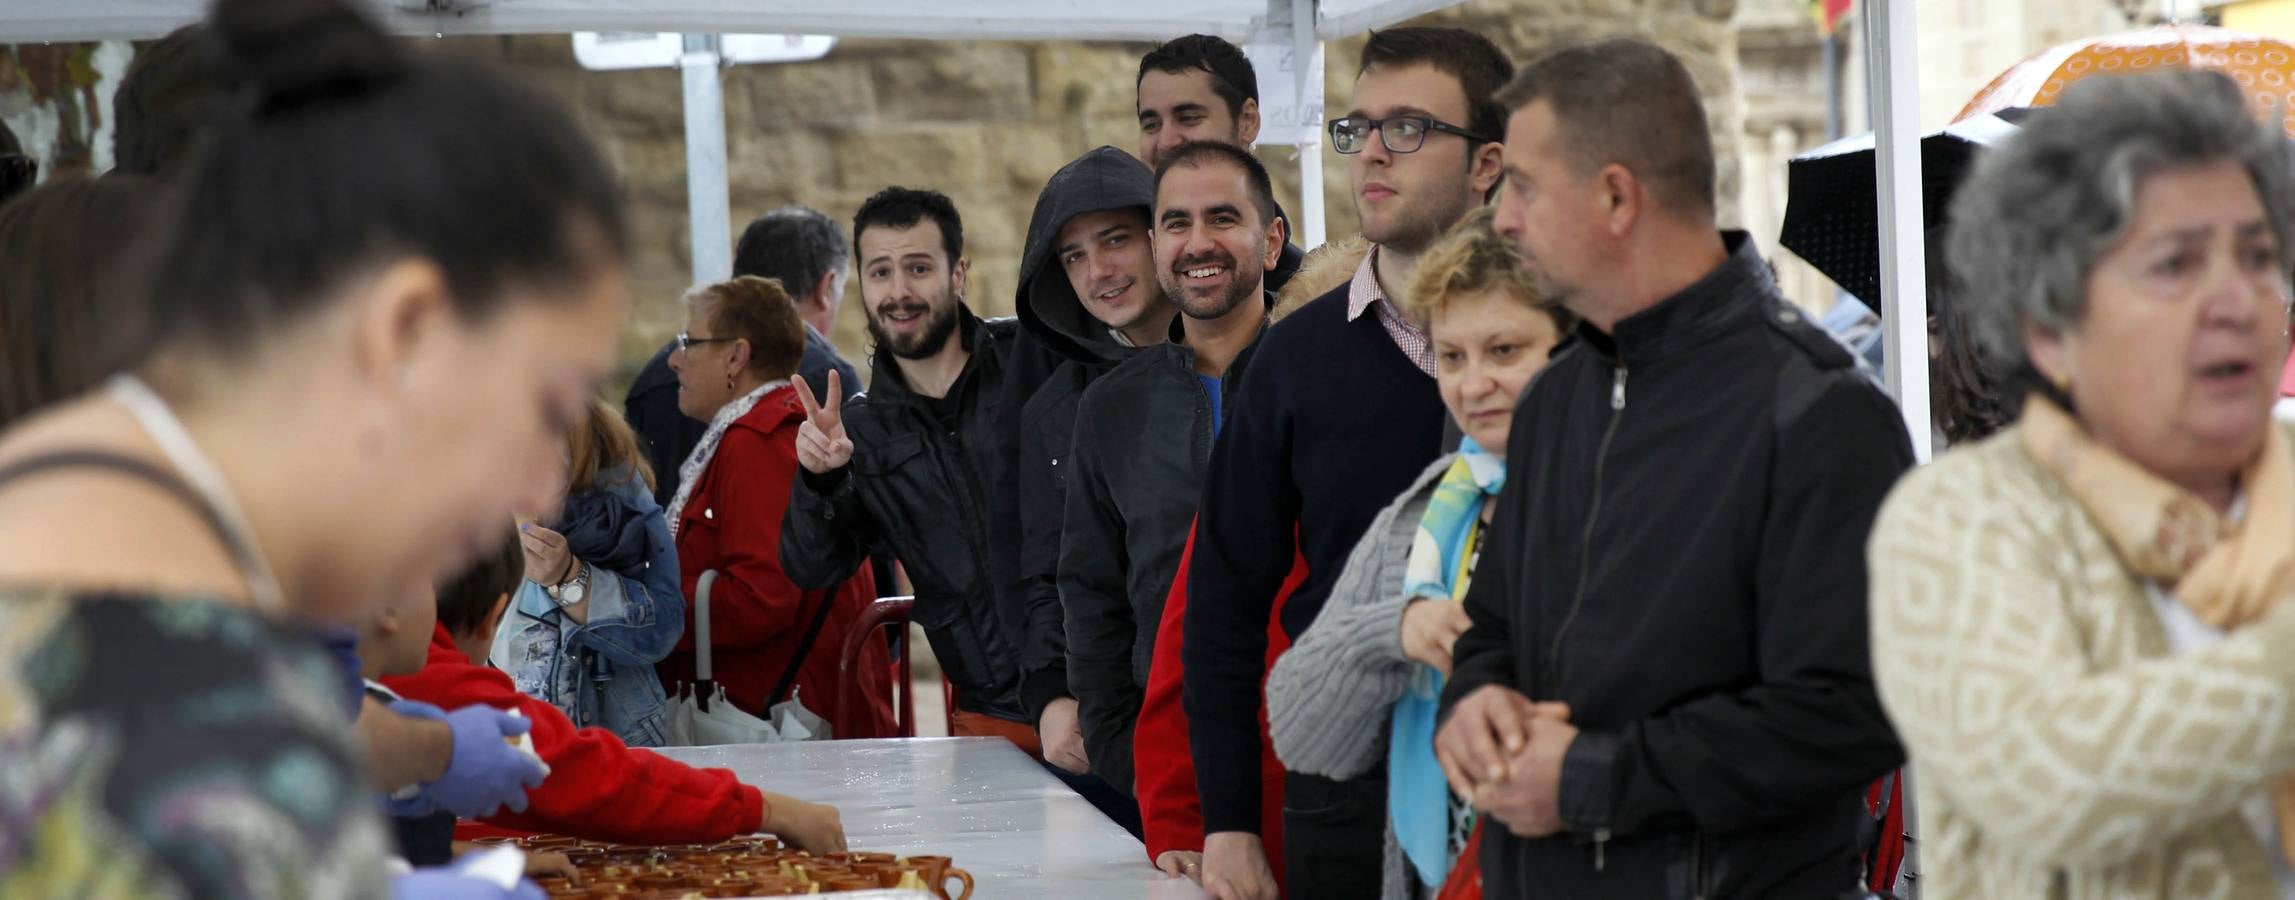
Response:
[1267, 455, 1455, 900]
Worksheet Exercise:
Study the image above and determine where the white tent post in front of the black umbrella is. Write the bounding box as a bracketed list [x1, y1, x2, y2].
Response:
[1861, 0, 1935, 461]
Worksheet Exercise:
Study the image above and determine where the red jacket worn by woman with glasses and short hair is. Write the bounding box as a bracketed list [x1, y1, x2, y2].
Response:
[659, 386, 893, 737]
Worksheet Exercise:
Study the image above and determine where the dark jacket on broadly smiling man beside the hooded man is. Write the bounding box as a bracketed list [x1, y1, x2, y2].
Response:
[1060, 305, 1274, 794]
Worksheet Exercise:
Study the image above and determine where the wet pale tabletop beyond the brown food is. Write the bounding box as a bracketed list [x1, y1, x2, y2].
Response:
[659, 737, 1205, 900]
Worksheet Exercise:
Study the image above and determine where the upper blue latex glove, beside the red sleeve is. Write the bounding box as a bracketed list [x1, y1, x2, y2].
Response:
[390, 700, 549, 820]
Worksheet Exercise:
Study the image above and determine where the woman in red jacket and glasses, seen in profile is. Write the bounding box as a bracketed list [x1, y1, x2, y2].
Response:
[661, 276, 893, 737]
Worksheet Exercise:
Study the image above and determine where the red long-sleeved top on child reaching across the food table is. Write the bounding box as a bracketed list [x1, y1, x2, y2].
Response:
[383, 624, 764, 845]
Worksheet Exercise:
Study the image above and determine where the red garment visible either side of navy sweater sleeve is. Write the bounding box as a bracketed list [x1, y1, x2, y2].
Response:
[1131, 526, 1306, 884]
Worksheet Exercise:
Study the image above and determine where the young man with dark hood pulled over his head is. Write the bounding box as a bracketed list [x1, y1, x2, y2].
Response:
[1008, 147, 1177, 776]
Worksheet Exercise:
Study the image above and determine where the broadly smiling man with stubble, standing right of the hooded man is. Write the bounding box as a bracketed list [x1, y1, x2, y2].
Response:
[1060, 140, 1283, 794]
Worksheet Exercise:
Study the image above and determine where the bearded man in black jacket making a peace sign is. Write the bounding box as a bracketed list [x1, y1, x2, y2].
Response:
[780, 188, 1042, 743]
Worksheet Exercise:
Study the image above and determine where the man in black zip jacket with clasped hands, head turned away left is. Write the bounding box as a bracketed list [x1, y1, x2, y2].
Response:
[1434, 39, 1912, 900]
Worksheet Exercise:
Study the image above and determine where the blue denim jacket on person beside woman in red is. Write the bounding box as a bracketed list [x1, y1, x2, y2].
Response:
[491, 468, 686, 746]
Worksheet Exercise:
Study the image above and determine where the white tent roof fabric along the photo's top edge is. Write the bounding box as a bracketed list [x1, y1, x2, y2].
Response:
[0, 0, 1457, 44]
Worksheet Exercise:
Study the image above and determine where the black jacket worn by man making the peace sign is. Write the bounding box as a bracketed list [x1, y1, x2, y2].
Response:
[780, 305, 1035, 726]
